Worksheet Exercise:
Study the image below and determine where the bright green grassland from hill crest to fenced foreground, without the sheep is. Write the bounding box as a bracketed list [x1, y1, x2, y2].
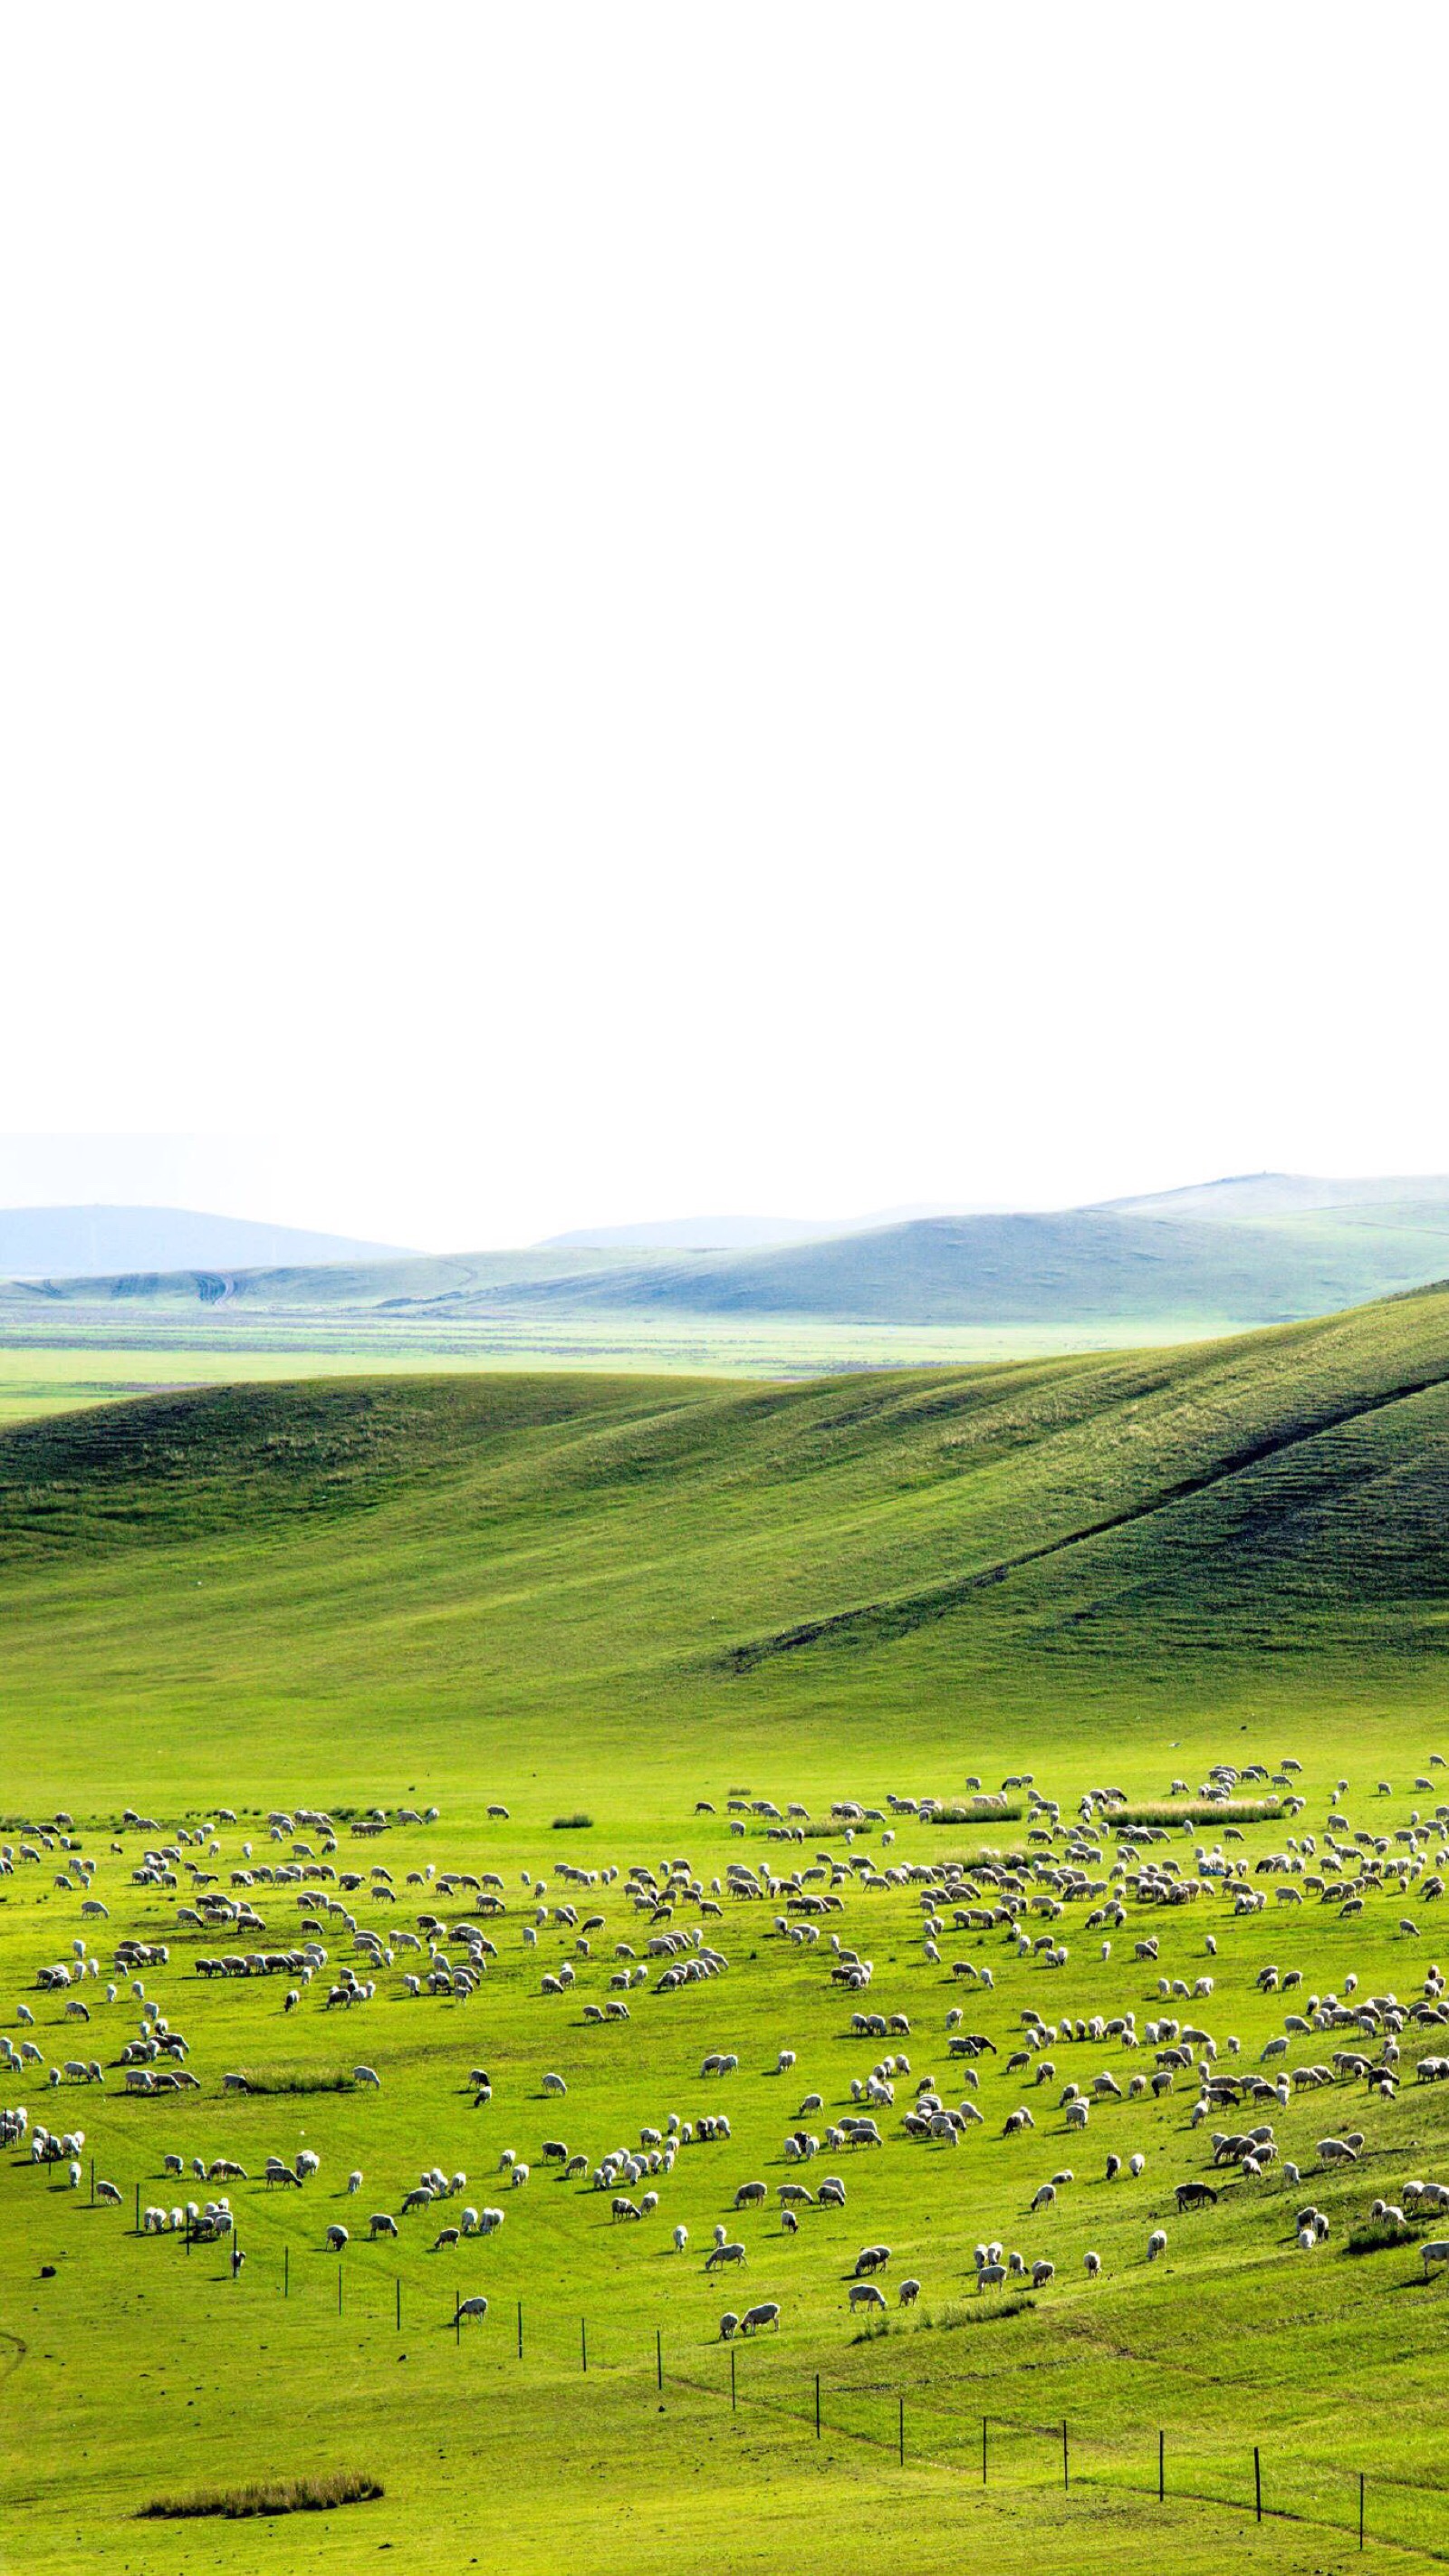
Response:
[0, 1291, 1449, 2576]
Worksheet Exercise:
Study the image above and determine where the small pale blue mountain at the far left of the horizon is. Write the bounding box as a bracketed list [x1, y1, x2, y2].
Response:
[0, 1208, 398, 1280]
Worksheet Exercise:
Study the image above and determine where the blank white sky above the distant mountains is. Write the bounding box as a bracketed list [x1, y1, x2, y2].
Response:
[0, 0, 1449, 1245]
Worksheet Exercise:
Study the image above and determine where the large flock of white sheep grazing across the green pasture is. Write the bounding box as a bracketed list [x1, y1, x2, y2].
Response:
[0, 1754, 1449, 2339]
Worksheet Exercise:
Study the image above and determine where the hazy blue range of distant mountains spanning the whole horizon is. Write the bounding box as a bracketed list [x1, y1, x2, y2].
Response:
[0, 1172, 1449, 1350]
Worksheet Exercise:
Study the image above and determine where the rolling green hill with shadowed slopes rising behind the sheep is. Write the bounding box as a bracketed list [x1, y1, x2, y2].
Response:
[0, 1291, 1449, 1813]
